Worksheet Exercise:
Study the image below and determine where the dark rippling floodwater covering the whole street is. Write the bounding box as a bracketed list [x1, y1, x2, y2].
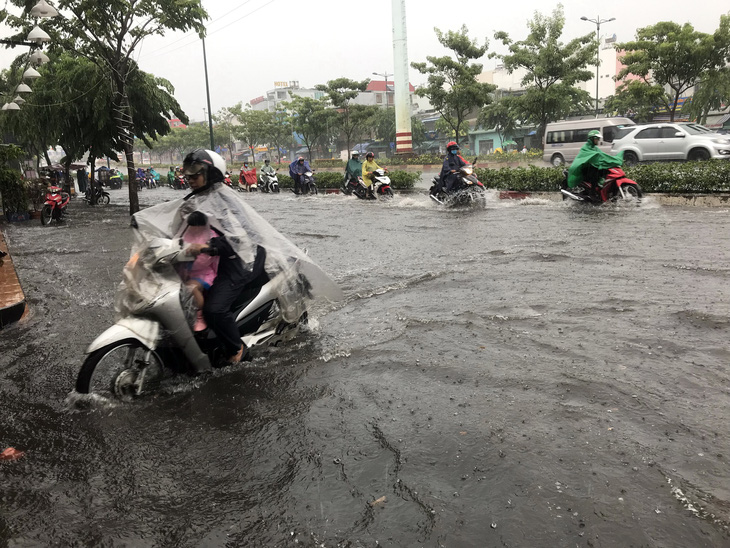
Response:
[0, 189, 730, 548]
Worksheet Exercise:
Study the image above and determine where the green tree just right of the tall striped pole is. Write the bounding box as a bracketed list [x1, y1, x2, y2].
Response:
[411, 25, 496, 143]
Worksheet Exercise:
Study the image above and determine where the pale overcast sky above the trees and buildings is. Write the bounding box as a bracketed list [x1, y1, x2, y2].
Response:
[3, 0, 730, 120]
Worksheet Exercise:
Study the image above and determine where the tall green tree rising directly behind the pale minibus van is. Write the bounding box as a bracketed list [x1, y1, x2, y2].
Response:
[493, 5, 598, 147]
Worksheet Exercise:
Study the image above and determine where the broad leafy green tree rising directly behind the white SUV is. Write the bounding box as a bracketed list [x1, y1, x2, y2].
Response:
[616, 15, 730, 121]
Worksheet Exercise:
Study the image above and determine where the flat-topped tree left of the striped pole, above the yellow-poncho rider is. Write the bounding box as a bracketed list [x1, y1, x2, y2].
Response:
[315, 78, 378, 158]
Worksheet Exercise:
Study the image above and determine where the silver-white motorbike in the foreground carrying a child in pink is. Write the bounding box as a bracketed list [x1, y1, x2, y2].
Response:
[76, 246, 307, 400]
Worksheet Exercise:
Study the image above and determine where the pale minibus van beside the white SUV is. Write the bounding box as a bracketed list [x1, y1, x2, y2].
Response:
[542, 118, 634, 166]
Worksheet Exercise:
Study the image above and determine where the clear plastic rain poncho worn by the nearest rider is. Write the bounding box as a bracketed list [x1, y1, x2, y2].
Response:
[115, 183, 342, 323]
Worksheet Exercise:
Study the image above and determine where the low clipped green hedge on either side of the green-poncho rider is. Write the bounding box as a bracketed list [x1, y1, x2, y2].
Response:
[476, 160, 730, 194]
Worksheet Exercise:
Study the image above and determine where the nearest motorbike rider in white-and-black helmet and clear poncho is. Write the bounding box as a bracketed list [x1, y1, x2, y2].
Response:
[115, 149, 342, 363]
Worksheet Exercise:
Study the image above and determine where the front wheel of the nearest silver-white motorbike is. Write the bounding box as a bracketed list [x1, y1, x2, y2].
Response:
[76, 339, 162, 400]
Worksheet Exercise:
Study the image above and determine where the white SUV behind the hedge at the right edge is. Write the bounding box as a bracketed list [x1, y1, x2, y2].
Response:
[611, 122, 730, 165]
